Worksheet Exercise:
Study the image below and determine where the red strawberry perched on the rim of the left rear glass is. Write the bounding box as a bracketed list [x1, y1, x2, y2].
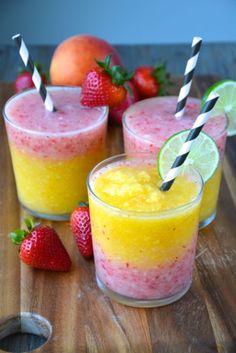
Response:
[80, 55, 131, 108]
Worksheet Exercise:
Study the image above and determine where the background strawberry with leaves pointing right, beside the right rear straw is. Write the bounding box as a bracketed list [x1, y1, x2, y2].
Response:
[132, 64, 171, 99]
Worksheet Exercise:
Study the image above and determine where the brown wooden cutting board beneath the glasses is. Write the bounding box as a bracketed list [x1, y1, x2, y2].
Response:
[0, 76, 236, 353]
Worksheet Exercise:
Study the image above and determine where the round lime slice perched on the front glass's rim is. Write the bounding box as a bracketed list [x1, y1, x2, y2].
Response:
[157, 130, 220, 182]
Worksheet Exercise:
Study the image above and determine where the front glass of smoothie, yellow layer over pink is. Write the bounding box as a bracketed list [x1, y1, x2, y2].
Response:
[88, 156, 202, 307]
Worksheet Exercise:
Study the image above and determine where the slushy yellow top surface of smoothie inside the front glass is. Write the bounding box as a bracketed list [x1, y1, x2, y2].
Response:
[95, 166, 197, 212]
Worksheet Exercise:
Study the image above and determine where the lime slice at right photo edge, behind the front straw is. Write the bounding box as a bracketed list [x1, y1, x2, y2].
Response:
[202, 80, 236, 136]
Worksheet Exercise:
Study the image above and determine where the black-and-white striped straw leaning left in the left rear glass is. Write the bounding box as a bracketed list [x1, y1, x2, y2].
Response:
[12, 34, 56, 112]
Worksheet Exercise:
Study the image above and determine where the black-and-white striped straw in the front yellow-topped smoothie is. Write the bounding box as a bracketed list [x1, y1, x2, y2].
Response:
[160, 93, 219, 191]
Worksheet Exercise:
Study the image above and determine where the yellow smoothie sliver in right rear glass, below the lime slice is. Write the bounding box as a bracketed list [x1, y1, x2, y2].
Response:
[200, 164, 222, 222]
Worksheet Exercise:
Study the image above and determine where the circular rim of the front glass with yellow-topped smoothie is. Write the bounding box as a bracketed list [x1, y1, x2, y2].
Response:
[86, 152, 204, 218]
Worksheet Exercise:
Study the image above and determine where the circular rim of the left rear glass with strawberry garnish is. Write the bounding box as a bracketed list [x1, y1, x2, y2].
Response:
[2, 85, 109, 137]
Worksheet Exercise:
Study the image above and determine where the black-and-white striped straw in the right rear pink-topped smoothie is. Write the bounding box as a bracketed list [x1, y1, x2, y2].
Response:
[175, 37, 202, 118]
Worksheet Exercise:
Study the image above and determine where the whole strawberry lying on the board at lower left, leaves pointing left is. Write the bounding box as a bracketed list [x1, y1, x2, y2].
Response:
[10, 219, 71, 271]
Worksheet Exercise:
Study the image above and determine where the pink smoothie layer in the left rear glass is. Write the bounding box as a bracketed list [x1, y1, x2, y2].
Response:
[5, 87, 106, 159]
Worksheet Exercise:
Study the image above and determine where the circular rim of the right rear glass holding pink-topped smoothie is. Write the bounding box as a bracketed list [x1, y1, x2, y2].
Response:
[122, 95, 229, 145]
